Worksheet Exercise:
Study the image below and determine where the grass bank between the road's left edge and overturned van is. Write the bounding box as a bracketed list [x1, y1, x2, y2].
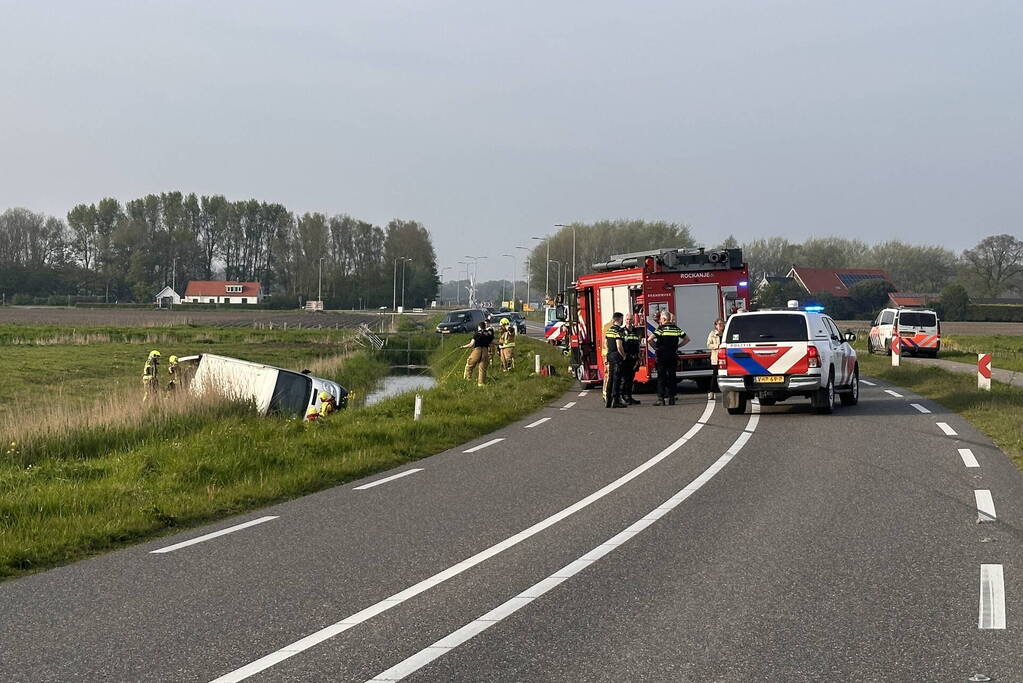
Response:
[0, 339, 572, 577]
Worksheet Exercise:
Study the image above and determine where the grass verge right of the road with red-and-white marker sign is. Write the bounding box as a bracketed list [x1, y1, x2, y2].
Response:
[856, 343, 1023, 469]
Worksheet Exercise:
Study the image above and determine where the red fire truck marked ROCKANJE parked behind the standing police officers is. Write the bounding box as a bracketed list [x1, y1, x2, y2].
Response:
[559, 248, 750, 391]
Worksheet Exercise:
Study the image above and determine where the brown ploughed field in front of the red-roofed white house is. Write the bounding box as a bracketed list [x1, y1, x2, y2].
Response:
[0, 306, 390, 329]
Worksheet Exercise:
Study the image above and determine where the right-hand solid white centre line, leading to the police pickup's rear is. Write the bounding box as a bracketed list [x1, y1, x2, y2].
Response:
[368, 402, 760, 683]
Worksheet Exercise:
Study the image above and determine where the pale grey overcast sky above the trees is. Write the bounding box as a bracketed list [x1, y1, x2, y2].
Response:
[0, 0, 1023, 279]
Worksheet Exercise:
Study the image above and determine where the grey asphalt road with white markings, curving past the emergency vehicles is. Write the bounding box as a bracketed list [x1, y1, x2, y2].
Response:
[0, 376, 1023, 681]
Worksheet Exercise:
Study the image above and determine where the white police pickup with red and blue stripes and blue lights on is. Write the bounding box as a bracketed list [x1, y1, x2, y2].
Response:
[717, 304, 859, 415]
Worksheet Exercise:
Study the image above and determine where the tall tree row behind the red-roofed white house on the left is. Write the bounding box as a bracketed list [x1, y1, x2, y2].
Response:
[0, 192, 439, 307]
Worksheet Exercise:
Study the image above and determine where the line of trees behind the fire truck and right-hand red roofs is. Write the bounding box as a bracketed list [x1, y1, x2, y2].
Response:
[529, 220, 1023, 299]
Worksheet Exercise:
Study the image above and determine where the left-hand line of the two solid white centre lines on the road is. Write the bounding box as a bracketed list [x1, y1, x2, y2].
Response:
[211, 400, 716, 683]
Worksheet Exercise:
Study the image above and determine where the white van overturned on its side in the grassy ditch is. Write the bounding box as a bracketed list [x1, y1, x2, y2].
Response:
[178, 354, 348, 418]
